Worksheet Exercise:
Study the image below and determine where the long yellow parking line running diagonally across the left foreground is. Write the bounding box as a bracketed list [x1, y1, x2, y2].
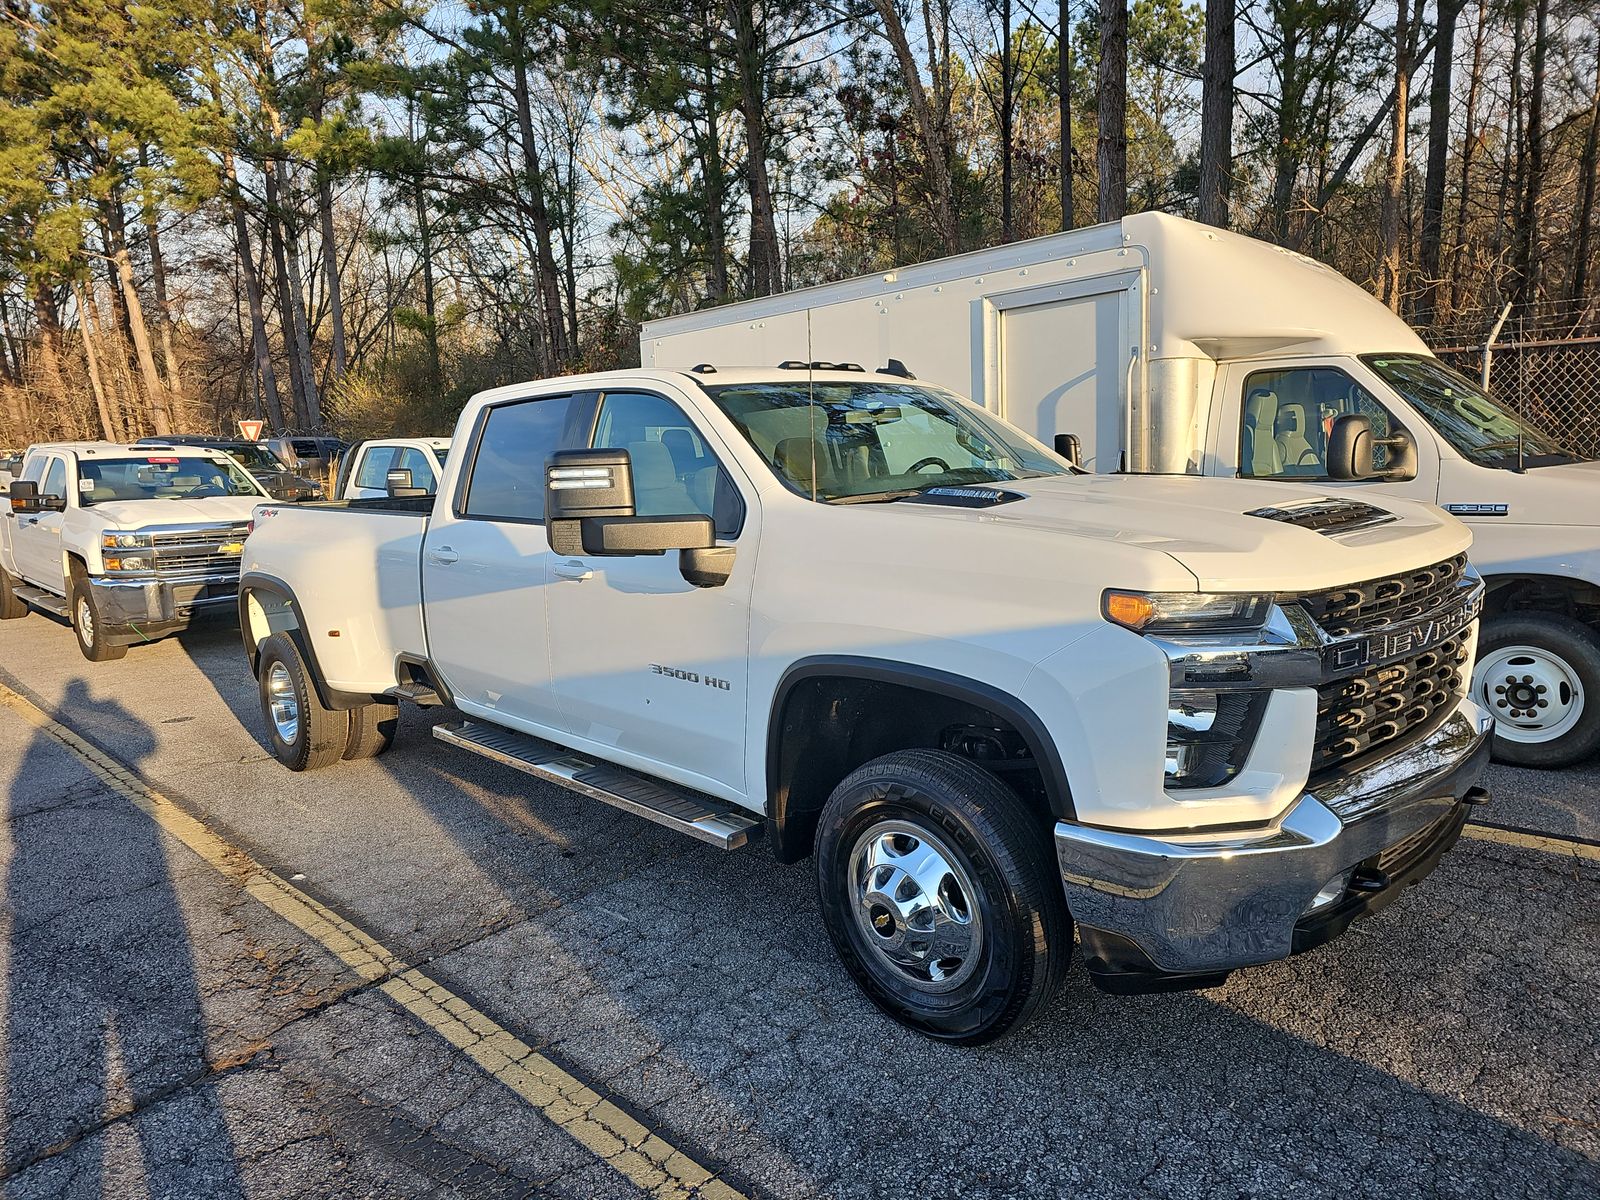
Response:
[0, 683, 744, 1200]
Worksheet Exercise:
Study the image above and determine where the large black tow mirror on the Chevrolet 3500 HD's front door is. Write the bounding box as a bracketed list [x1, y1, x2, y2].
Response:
[544, 450, 731, 587]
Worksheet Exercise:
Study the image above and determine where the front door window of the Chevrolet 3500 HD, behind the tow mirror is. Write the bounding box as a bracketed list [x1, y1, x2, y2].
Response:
[594, 392, 744, 538]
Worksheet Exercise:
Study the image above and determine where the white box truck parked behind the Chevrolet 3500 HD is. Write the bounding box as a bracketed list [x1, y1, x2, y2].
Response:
[640, 213, 1600, 766]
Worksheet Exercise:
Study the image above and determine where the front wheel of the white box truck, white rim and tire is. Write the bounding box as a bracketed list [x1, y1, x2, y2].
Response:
[1472, 613, 1600, 766]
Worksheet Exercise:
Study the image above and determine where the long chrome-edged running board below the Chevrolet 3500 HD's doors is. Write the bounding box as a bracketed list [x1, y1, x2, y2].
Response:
[434, 722, 762, 850]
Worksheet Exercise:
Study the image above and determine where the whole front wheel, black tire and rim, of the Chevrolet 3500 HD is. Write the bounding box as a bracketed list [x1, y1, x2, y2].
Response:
[816, 750, 1072, 1043]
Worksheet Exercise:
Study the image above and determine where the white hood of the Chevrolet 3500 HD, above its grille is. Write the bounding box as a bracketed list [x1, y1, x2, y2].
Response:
[888, 475, 1472, 592]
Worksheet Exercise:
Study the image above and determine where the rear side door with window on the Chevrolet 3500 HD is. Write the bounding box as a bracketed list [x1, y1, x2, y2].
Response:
[422, 394, 590, 733]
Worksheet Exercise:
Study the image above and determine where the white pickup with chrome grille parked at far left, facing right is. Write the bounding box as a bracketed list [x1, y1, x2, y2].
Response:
[0, 442, 267, 662]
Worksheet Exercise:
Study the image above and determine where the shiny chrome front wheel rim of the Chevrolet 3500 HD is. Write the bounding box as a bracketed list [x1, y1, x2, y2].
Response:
[850, 821, 984, 992]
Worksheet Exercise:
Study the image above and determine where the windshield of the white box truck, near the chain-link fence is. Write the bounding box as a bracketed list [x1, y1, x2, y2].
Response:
[1362, 354, 1579, 467]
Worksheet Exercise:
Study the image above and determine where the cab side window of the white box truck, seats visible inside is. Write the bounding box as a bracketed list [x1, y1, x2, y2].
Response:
[1238, 366, 1390, 478]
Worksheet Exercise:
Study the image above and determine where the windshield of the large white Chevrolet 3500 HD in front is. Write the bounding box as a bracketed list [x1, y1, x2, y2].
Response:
[706, 379, 1070, 501]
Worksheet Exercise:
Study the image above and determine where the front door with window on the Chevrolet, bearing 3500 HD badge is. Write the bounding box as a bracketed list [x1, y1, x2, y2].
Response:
[547, 389, 757, 798]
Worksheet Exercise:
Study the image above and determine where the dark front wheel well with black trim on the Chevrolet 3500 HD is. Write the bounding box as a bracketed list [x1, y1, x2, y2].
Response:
[766, 670, 1070, 862]
